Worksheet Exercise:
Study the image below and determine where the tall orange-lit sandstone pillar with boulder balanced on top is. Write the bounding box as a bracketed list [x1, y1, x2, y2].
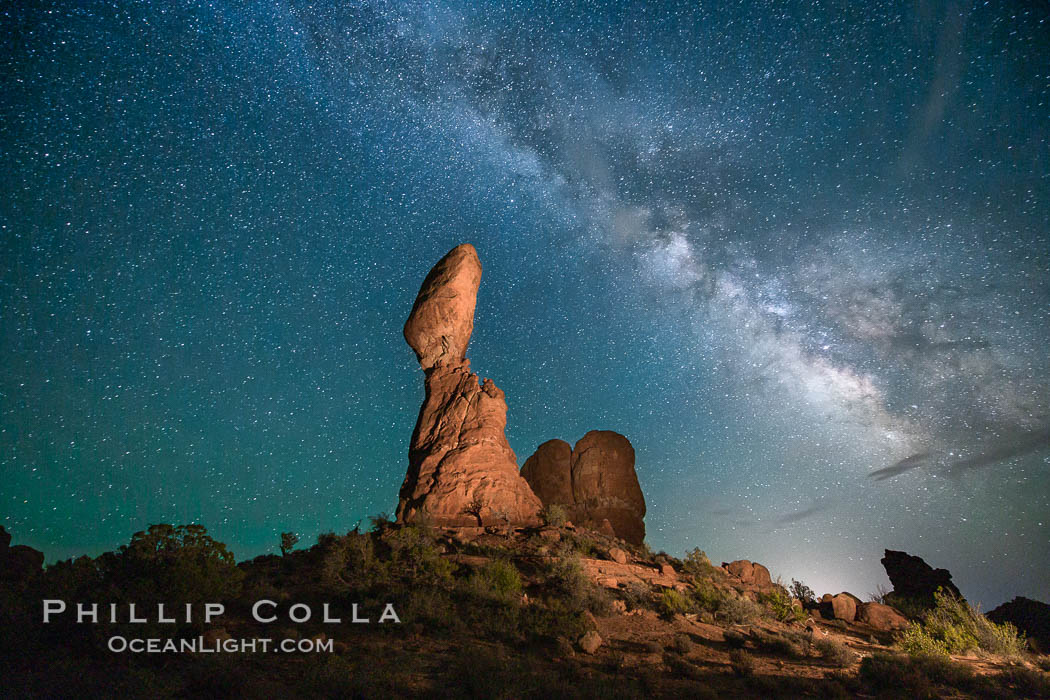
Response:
[397, 243, 541, 526]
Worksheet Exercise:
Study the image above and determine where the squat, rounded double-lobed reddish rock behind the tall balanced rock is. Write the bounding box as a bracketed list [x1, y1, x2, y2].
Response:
[521, 430, 646, 545]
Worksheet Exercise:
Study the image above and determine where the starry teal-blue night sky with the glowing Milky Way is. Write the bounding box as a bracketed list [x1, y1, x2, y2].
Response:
[0, 0, 1050, 610]
